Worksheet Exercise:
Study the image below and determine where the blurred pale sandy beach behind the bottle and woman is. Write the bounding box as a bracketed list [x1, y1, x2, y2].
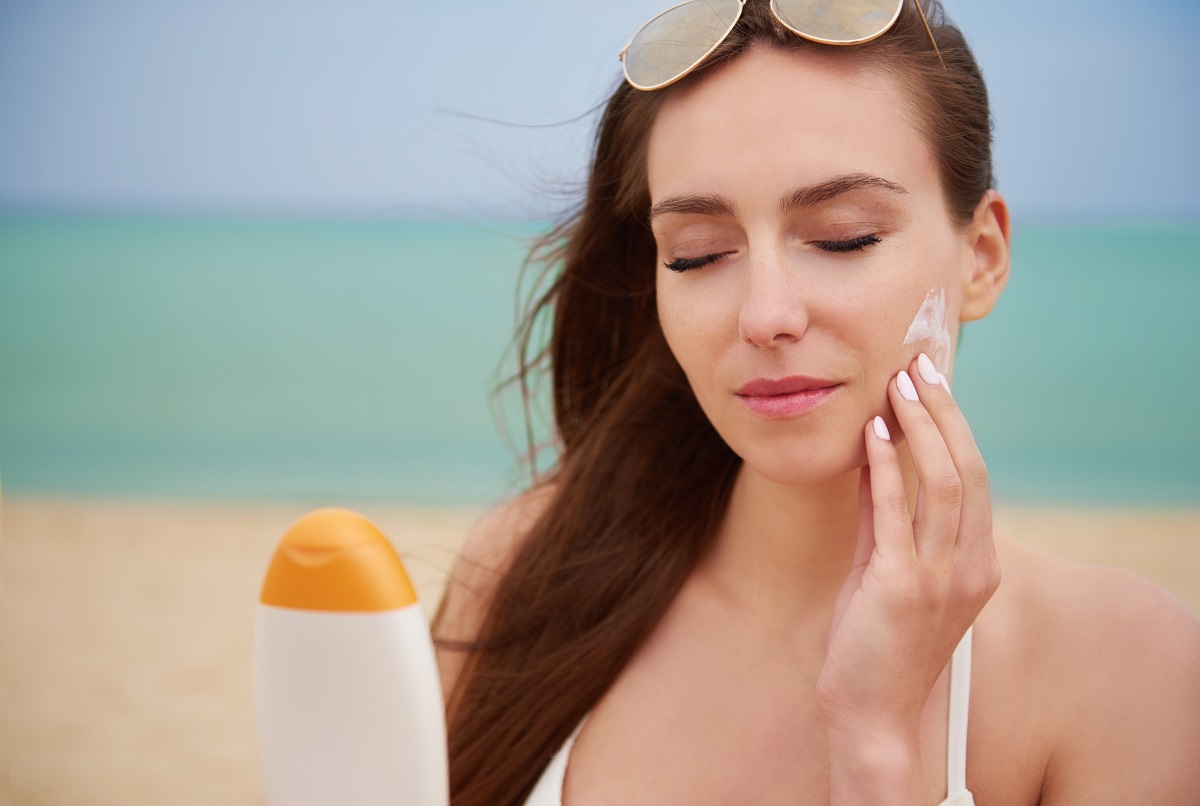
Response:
[0, 497, 1200, 806]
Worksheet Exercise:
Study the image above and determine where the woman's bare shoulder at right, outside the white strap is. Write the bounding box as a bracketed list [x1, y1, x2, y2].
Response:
[980, 539, 1200, 806]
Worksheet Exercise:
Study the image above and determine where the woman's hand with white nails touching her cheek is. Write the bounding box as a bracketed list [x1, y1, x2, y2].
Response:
[817, 354, 1000, 766]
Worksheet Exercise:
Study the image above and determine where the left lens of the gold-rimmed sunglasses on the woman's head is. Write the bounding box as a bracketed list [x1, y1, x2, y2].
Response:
[624, 0, 742, 90]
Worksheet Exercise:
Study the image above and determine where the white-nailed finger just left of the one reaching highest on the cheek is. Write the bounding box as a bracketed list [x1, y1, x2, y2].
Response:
[888, 369, 962, 555]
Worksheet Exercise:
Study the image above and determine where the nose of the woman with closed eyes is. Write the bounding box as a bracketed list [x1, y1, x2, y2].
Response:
[738, 247, 809, 347]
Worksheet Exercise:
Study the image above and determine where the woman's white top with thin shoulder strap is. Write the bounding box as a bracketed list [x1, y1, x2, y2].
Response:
[524, 630, 974, 806]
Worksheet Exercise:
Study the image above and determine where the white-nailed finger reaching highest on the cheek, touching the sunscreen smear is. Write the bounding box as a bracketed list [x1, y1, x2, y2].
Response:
[912, 353, 991, 551]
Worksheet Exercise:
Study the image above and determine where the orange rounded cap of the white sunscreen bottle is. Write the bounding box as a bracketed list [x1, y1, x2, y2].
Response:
[259, 510, 416, 612]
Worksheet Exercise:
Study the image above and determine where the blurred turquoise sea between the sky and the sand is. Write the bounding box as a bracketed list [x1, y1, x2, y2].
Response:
[0, 215, 1200, 505]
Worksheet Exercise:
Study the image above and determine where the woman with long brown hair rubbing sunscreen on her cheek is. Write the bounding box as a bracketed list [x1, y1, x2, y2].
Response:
[434, 0, 1200, 806]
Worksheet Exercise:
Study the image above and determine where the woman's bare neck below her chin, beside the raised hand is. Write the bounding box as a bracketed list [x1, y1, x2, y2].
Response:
[701, 443, 917, 621]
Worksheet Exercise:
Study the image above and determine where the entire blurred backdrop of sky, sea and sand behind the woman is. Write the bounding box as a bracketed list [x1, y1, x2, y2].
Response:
[0, 0, 1200, 804]
